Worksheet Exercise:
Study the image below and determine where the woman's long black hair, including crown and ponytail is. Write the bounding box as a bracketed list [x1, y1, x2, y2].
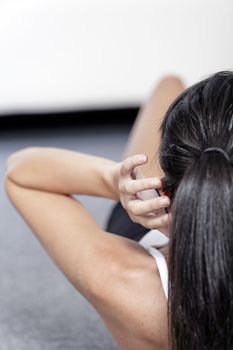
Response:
[159, 71, 233, 350]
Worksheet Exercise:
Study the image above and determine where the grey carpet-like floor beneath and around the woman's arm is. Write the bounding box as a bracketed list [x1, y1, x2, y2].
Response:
[0, 126, 130, 350]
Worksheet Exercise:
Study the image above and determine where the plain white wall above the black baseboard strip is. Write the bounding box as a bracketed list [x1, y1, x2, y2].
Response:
[0, 0, 233, 113]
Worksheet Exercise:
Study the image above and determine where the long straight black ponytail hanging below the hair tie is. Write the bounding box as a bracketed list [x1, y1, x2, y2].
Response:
[169, 152, 233, 350]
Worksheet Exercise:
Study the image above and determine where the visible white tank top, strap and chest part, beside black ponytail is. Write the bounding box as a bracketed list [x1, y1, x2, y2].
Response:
[138, 230, 169, 300]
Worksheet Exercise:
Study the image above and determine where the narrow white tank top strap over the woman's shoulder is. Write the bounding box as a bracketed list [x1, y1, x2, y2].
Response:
[146, 247, 168, 300]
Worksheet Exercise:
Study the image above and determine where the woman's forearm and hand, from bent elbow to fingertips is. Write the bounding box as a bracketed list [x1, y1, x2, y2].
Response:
[7, 147, 170, 233]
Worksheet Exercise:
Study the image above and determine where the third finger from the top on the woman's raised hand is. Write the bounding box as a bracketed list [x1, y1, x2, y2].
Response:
[128, 196, 170, 215]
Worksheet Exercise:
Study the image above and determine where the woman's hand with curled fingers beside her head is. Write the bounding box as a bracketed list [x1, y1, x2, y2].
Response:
[107, 154, 171, 235]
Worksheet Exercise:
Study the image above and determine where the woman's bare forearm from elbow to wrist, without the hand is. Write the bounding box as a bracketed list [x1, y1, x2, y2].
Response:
[7, 147, 119, 200]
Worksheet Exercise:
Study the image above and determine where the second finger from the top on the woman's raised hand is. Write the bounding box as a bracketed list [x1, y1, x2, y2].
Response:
[120, 177, 162, 196]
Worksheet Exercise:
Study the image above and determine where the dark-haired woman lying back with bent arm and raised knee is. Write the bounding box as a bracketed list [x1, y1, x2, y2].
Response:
[6, 72, 233, 350]
